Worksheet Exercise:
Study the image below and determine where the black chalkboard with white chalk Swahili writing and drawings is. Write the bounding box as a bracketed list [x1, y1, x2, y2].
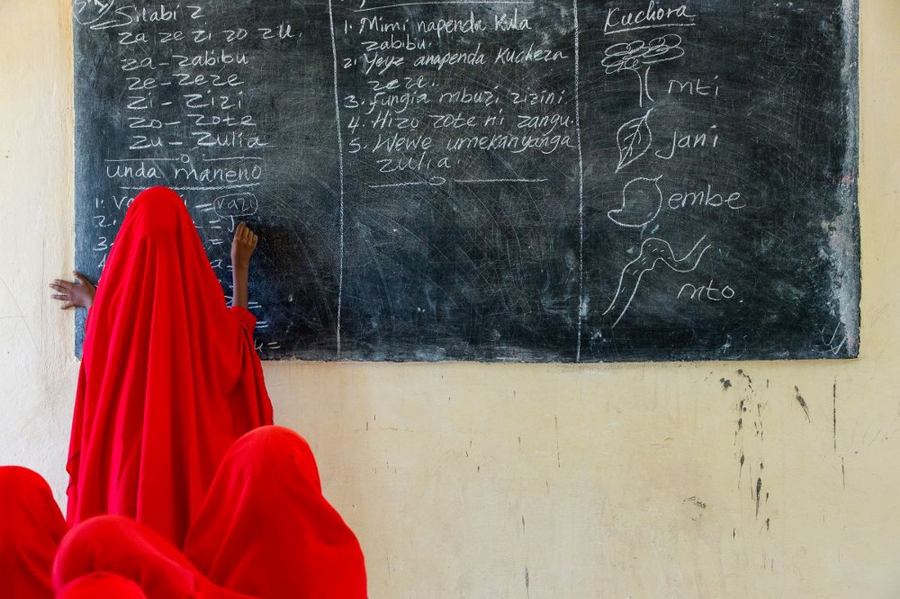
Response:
[73, 0, 860, 362]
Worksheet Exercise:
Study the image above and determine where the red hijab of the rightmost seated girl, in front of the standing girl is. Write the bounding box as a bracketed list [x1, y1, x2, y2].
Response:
[184, 426, 366, 599]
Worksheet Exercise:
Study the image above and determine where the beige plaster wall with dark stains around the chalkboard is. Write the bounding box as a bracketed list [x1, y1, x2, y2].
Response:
[0, 0, 900, 599]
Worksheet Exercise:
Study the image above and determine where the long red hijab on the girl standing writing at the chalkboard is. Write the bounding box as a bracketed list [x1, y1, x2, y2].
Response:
[66, 187, 272, 547]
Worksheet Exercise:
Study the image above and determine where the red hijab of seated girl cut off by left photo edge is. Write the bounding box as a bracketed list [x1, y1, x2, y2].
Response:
[0, 466, 66, 599]
